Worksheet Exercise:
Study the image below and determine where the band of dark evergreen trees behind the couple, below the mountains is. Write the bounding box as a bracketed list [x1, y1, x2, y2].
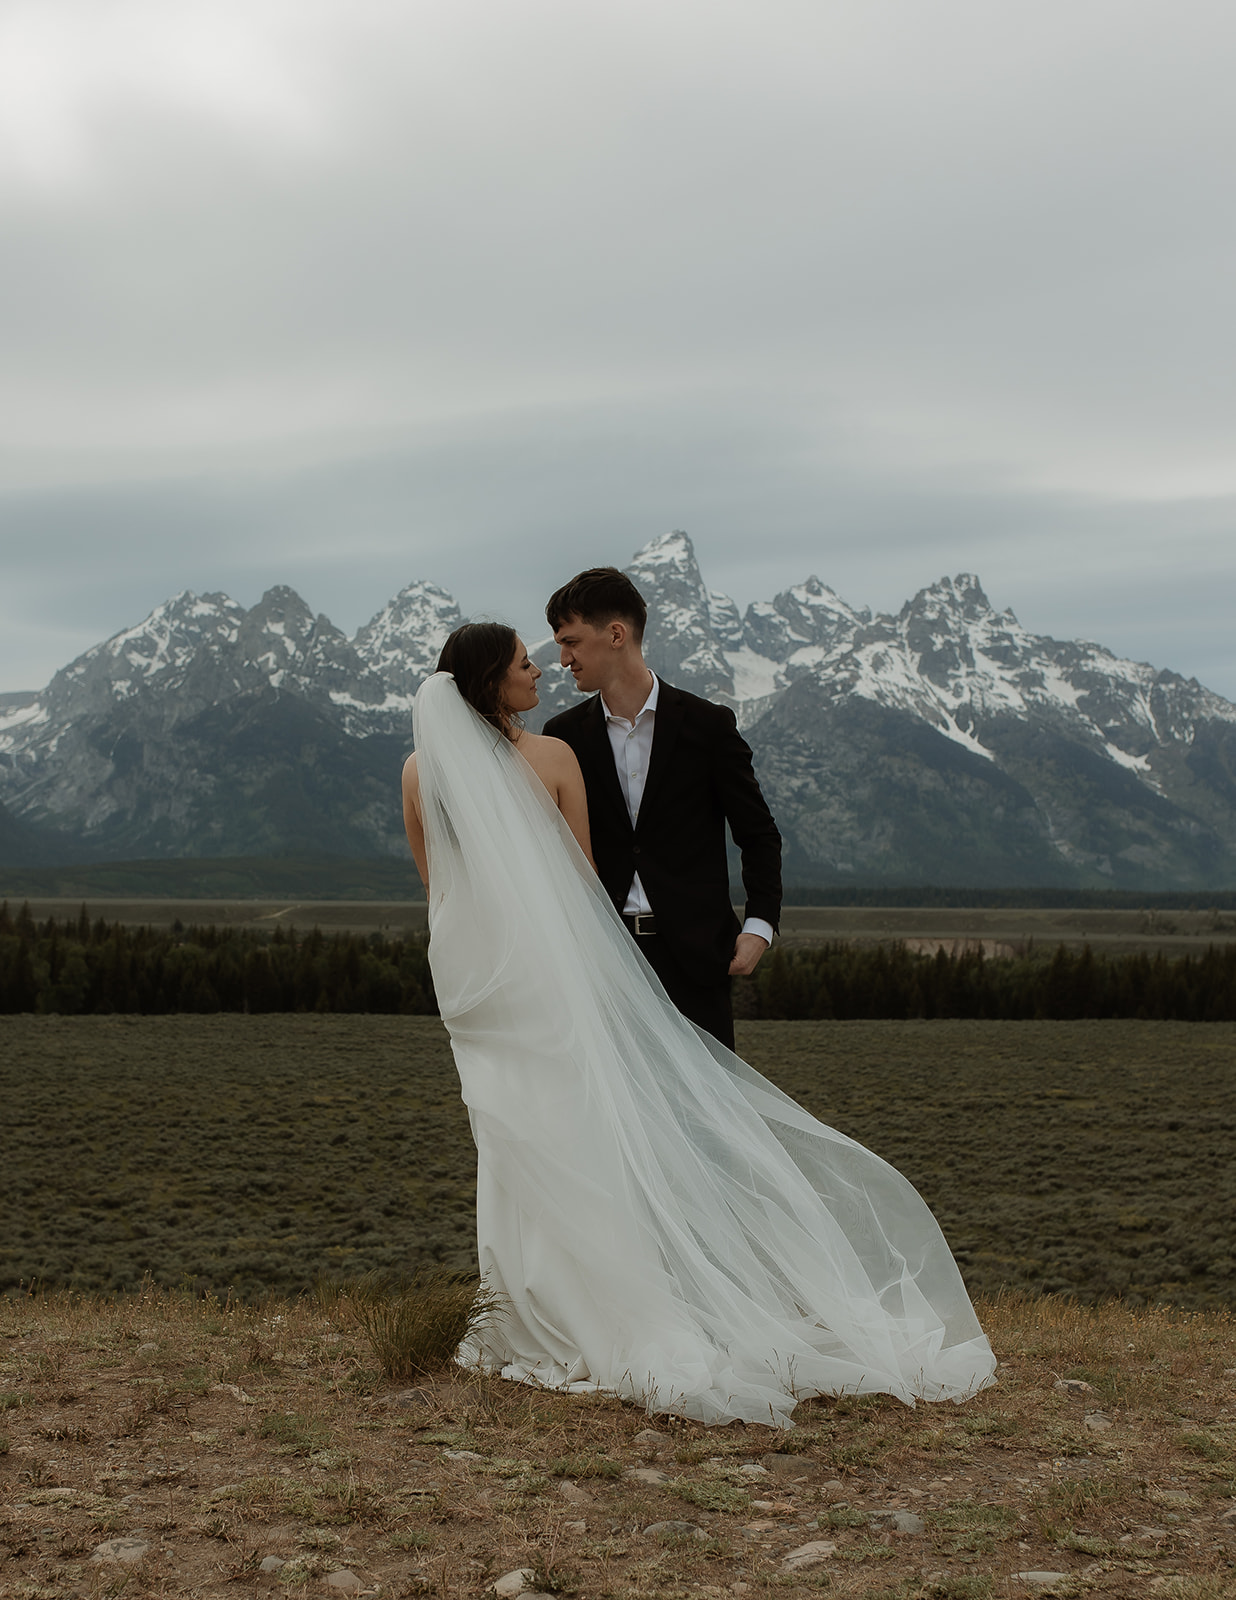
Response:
[0, 902, 1236, 1022]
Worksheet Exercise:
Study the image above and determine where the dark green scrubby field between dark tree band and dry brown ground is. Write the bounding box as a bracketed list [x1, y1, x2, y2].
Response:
[0, 1014, 1236, 1307]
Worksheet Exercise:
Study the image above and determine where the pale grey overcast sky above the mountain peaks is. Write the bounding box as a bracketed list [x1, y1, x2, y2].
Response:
[0, 0, 1236, 699]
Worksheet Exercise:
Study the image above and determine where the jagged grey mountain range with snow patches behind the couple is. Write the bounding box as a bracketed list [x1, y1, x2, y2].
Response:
[0, 533, 1236, 890]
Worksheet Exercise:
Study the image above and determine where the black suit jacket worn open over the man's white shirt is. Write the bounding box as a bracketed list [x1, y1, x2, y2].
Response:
[544, 682, 781, 986]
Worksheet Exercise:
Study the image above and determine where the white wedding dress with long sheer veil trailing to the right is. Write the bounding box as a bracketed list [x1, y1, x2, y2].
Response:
[413, 674, 996, 1427]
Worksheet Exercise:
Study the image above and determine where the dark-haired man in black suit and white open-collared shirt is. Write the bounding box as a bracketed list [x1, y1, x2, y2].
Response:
[544, 566, 781, 1050]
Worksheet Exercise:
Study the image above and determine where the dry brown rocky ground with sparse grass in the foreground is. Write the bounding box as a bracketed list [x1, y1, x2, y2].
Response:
[0, 1290, 1236, 1600]
